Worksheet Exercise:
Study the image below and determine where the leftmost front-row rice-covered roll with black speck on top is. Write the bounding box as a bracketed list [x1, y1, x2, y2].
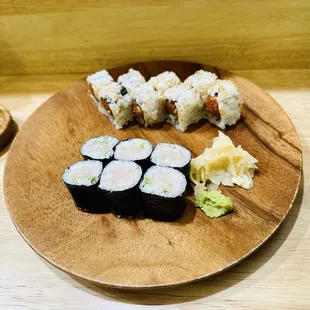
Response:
[98, 82, 133, 129]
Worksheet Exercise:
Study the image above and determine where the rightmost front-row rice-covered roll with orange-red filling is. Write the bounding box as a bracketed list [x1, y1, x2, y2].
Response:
[202, 80, 243, 129]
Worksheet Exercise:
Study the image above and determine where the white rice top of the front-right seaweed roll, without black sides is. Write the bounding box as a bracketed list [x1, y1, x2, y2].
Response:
[139, 166, 186, 198]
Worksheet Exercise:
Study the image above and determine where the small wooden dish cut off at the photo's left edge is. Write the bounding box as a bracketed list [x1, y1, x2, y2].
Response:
[0, 105, 16, 151]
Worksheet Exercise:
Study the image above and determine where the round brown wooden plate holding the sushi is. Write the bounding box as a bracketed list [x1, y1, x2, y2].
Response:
[4, 62, 302, 289]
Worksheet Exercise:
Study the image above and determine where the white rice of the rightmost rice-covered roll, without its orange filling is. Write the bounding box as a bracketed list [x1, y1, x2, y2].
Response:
[205, 80, 243, 129]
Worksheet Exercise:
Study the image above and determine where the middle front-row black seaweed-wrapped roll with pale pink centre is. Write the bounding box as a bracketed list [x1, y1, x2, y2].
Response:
[99, 160, 143, 217]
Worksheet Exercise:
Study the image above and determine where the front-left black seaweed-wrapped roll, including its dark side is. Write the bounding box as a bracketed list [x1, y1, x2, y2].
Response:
[62, 160, 110, 213]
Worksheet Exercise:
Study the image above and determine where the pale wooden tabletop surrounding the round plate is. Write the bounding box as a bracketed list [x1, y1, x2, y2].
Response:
[0, 70, 310, 310]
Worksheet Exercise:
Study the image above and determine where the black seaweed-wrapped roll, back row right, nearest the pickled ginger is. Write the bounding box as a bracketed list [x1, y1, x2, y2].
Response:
[151, 143, 192, 178]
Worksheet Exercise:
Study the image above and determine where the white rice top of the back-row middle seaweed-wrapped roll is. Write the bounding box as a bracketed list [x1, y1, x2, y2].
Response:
[114, 138, 153, 161]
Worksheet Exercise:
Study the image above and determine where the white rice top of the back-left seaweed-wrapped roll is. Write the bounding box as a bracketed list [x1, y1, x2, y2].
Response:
[81, 136, 118, 159]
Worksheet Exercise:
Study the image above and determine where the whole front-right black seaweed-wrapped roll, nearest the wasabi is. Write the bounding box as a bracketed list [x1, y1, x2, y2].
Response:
[139, 166, 186, 222]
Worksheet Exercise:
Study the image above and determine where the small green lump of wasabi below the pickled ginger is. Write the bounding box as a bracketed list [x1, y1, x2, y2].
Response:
[196, 191, 233, 218]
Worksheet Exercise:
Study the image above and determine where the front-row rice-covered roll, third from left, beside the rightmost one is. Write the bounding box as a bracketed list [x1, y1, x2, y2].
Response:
[163, 85, 203, 131]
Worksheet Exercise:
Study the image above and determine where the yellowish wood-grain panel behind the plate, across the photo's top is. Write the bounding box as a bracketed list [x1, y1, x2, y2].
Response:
[0, 0, 310, 75]
